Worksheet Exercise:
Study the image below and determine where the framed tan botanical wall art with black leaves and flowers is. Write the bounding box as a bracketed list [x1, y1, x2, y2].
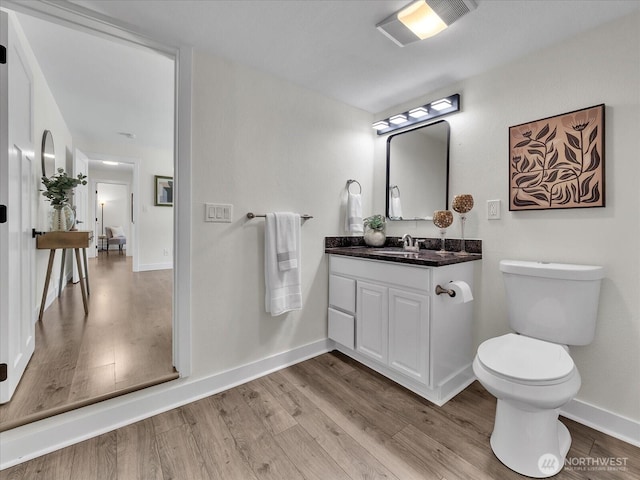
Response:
[509, 105, 605, 210]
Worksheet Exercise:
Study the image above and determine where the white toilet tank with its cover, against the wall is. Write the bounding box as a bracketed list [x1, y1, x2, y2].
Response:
[500, 260, 604, 345]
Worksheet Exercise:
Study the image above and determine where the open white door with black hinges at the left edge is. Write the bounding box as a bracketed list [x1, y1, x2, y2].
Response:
[0, 12, 36, 403]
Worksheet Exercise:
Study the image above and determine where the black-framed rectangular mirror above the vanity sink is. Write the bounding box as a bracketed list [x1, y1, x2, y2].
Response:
[386, 120, 449, 220]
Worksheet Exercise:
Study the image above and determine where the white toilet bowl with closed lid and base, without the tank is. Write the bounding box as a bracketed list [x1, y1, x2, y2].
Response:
[473, 334, 581, 478]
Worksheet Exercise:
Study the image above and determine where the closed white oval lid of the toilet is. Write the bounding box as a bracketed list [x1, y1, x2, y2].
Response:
[478, 333, 574, 382]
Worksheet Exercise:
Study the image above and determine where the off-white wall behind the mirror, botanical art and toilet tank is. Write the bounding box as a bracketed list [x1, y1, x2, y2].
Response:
[375, 14, 640, 421]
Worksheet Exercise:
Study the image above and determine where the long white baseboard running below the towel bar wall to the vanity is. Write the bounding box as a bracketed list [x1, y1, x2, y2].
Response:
[0, 339, 331, 470]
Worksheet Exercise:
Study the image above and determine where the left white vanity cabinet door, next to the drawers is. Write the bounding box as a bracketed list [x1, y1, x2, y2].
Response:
[356, 281, 389, 363]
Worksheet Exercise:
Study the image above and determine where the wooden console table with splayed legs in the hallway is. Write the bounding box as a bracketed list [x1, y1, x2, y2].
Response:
[36, 231, 93, 321]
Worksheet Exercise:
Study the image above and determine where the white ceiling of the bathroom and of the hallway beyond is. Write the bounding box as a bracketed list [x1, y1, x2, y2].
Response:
[10, 0, 640, 154]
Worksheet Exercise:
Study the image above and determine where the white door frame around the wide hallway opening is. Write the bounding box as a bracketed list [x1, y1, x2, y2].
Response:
[2, 0, 193, 378]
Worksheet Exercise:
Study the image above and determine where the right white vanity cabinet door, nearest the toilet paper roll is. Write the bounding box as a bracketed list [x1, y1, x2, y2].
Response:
[388, 288, 429, 384]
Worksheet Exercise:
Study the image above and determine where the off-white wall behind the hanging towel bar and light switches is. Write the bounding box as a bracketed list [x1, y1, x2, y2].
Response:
[191, 54, 373, 376]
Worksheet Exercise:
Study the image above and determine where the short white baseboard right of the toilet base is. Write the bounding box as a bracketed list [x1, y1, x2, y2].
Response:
[560, 399, 640, 447]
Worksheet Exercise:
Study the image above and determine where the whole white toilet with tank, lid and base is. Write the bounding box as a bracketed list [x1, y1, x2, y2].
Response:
[473, 260, 604, 478]
